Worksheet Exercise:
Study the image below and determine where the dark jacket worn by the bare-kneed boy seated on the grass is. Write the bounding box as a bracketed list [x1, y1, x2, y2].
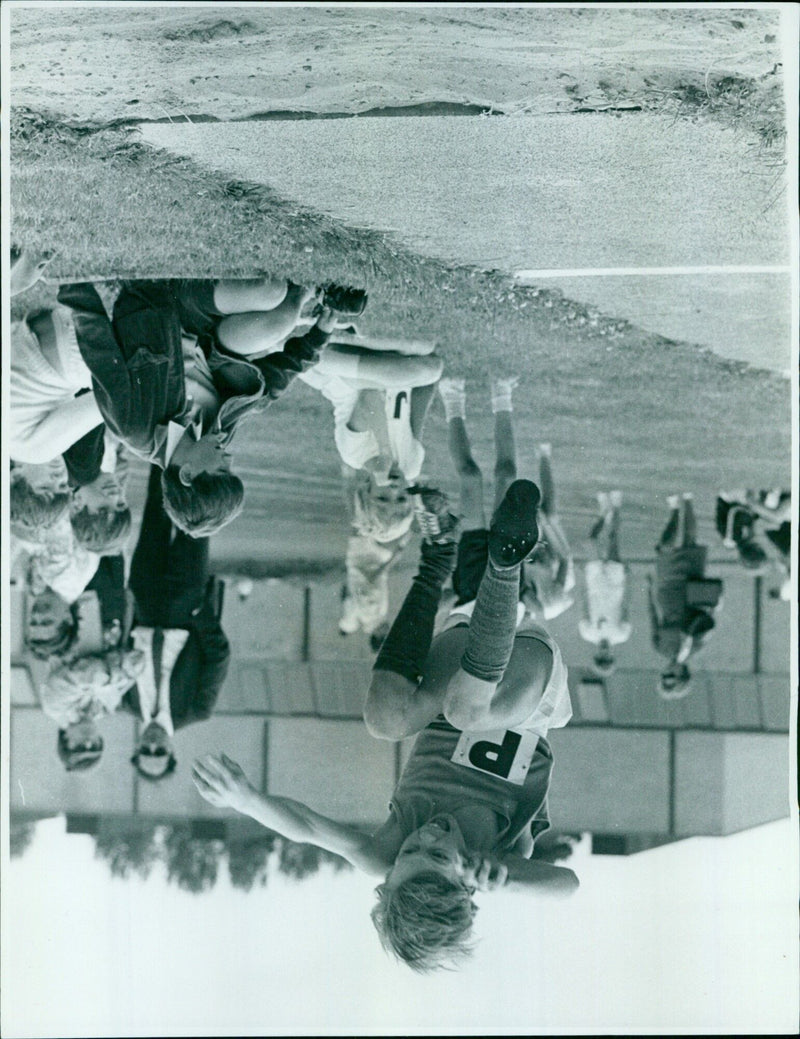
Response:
[58, 282, 329, 469]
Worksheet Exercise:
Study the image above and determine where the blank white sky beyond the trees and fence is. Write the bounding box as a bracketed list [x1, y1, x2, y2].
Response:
[2, 819, 798, 1037]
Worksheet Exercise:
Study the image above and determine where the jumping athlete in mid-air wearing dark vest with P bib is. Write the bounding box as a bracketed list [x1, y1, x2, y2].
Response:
[193, 480, 578, 971]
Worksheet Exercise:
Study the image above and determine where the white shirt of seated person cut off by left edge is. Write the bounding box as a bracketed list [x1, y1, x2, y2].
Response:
[4, 307, 103, 463]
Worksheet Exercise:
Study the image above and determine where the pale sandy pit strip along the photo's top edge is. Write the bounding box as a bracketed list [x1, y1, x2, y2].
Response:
[10, 3, 780, 123]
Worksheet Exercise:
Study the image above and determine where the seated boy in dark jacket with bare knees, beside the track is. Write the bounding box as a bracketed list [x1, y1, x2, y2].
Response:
[58, 277, 367, 537]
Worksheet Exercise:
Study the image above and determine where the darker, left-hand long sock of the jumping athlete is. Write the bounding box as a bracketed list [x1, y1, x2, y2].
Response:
[373, 542, 456, 685]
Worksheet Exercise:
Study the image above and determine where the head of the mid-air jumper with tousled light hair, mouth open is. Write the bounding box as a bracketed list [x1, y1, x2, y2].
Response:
[372, 815, 477, 973]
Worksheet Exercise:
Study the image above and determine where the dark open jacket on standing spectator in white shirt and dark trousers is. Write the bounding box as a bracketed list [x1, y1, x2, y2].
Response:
[121, 578, 231, 729]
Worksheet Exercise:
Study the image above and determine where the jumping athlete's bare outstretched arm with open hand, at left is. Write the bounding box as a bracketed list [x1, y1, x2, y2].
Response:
[192, 754, 385, 874]
